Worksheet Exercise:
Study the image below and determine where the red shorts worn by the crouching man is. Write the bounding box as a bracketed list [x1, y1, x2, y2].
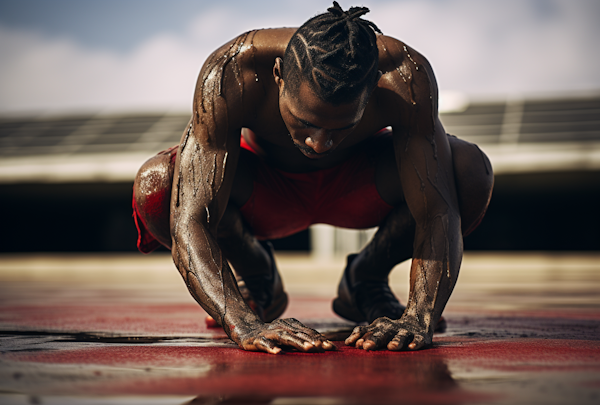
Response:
[133, 131, 393, 253]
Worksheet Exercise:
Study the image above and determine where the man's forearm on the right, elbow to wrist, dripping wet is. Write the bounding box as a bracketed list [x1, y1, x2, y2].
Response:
[402, 212, 463, 334]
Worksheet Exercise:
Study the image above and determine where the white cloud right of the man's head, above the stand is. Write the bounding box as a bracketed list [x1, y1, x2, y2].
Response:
[371, 0, 600, 94]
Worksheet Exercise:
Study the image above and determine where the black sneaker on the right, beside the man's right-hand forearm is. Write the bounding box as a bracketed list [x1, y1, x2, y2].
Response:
[333, 254, 406, 323]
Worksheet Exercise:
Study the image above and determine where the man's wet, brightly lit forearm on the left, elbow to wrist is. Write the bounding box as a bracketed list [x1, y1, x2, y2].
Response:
[173, 221, 262, 344]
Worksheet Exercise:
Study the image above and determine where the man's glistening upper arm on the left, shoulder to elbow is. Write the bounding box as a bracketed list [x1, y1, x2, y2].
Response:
[171, 35, 253, 236]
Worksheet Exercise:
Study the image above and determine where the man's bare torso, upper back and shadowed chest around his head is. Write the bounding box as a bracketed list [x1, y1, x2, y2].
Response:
[204, 28, 424, 172]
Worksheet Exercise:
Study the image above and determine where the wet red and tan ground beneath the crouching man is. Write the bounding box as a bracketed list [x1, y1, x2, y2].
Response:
[0, 253, 600, 405]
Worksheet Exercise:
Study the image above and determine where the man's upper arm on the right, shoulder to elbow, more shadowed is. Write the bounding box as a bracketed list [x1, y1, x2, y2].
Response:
[388, 40, 459, 225]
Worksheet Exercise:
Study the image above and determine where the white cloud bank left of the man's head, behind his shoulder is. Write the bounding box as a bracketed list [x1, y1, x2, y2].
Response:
[0, 1, 318, 115]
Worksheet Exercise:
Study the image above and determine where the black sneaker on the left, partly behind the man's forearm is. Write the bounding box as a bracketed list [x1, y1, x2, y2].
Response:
[237, 241, 288, 322]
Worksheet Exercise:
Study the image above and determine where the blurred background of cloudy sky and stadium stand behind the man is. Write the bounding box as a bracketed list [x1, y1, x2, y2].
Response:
[0, 0, 600, 252]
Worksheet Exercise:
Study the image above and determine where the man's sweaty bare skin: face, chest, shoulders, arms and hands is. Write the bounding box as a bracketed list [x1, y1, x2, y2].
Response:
[171, 28, 463, 353]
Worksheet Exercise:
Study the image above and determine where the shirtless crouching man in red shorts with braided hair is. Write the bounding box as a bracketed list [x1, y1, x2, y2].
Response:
[134, 2, 493, 353]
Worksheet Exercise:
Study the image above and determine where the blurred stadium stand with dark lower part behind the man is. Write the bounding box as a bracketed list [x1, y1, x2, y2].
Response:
[0, 95, 600, 251]
